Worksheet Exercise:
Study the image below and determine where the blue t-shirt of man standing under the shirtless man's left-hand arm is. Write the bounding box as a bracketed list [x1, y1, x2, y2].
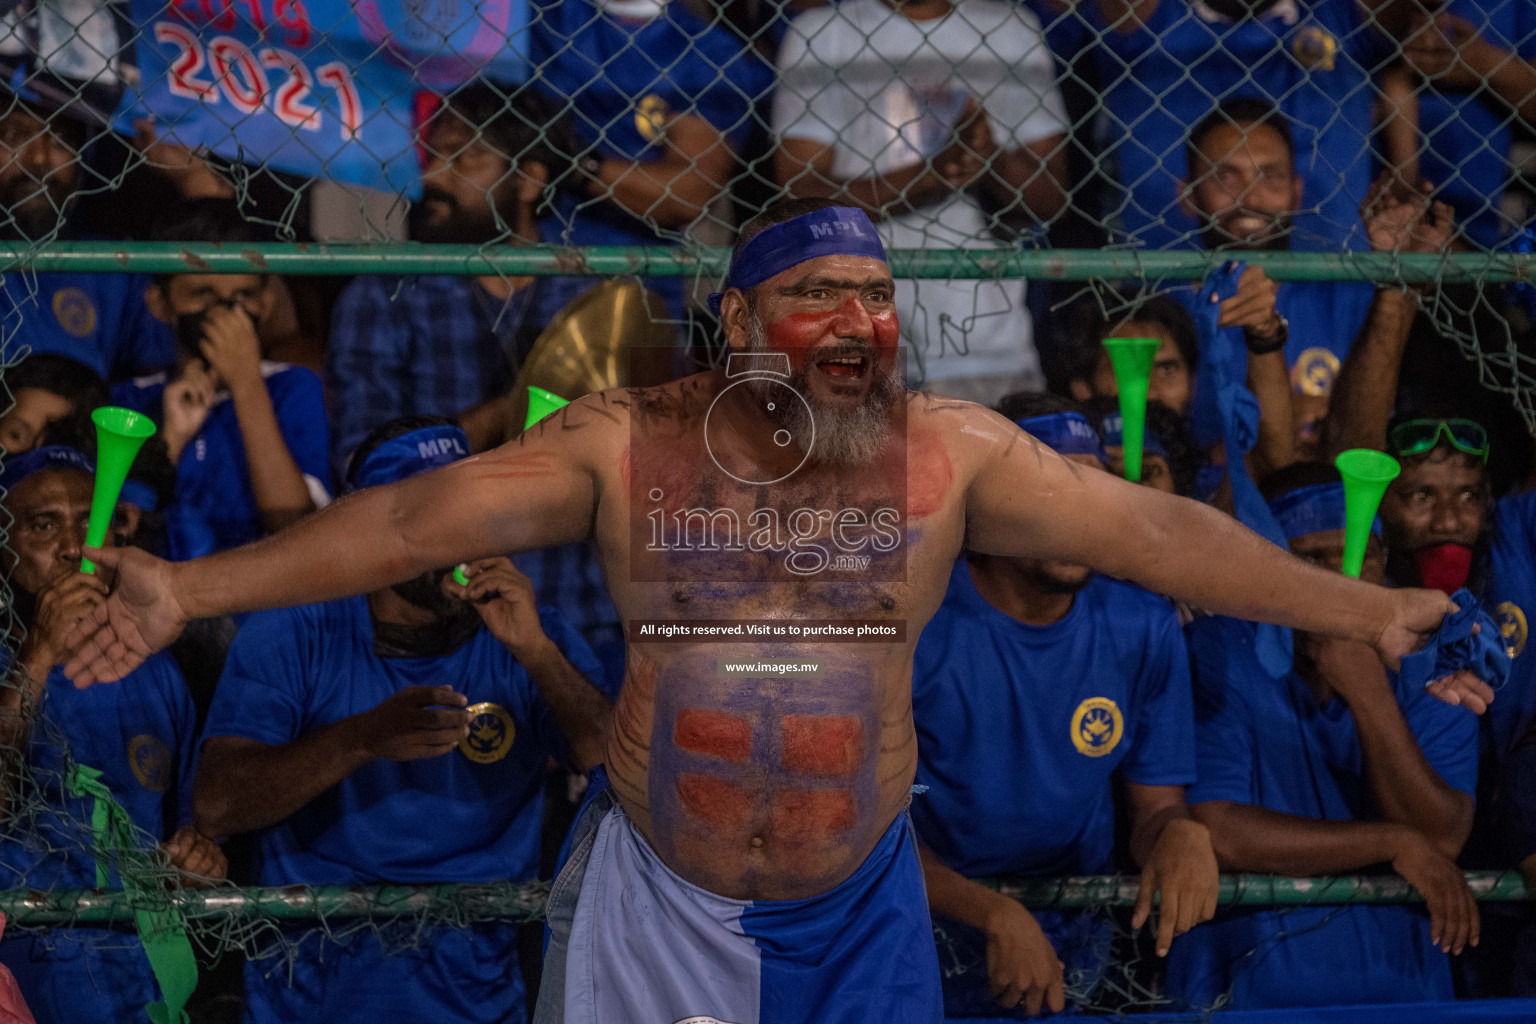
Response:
[204, 597, 604, 1024]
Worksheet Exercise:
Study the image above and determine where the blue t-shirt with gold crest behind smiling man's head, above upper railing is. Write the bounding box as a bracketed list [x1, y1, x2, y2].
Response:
[1081, 0, 1382, 250]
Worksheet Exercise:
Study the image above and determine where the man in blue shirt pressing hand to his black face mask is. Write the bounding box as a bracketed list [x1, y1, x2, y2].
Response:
[112, 198, 330, 550]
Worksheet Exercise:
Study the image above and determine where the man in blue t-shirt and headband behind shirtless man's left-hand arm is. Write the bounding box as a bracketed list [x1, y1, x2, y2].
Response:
[195, 416, 610, 1024]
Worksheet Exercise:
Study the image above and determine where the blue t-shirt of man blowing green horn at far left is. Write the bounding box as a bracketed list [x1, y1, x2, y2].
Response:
[0, 652, 197, 1024]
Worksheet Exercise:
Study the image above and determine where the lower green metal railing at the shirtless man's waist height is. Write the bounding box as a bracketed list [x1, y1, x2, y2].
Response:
[0, 872, 1536, 927]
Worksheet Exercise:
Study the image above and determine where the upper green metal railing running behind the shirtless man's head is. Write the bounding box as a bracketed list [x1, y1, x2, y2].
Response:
[0, 241, 1536, 282]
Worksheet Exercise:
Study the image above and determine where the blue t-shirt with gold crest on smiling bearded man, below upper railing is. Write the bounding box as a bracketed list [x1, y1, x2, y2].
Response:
[1169, 281, 1376, 395]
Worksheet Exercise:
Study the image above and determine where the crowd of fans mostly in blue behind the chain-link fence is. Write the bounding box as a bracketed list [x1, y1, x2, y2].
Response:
[0, 0, 1536, 1022]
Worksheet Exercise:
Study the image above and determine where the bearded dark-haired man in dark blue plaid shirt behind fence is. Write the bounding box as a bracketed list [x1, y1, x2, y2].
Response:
[326, 84, 562, 473]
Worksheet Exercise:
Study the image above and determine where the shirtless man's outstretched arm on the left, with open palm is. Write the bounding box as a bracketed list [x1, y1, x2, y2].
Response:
[66, 395, 624, 686]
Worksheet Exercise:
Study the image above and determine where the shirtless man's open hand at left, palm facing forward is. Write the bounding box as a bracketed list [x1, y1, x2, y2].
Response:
[63, 548, 187, 689]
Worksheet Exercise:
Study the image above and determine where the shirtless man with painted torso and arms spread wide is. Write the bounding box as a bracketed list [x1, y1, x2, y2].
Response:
[69, 200, 1480, 1024]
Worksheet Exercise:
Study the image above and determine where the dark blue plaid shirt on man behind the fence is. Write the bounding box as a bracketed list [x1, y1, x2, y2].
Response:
[326, 276, 539, 477]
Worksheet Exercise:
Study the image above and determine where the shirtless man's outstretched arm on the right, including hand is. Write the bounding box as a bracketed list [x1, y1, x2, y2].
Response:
[958, 404, 1455, 663]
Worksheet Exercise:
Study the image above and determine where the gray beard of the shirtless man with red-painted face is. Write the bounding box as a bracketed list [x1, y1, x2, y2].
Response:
[746, 310, 905, 465]
